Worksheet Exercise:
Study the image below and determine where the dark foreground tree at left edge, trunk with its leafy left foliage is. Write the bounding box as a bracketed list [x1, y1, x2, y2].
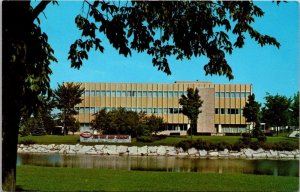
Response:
[2, 1, 56, 191]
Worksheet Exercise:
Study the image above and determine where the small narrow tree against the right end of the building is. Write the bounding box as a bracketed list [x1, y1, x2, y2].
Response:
[243, 94, 260, 128]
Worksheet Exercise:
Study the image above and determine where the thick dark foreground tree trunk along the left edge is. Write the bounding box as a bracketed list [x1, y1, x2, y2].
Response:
[2, 1, 32, 191]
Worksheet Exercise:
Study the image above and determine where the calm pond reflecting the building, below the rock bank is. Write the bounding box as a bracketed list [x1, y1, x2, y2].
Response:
[17, 154, 299, 177]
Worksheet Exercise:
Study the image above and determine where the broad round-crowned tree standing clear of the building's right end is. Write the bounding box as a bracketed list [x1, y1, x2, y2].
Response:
[262, 93, 291, 136]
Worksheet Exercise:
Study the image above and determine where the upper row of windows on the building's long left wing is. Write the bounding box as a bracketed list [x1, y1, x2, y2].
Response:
[84, 90, 185, 98]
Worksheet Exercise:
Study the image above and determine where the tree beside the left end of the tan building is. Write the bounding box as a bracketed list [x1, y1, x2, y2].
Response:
[54, 83, 84, 135]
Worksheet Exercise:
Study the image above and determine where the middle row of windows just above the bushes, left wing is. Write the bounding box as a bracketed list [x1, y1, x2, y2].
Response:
[75, 107, 182, 114]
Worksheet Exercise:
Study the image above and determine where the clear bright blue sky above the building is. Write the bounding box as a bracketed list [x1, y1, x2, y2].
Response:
[34, 1, 300, 103]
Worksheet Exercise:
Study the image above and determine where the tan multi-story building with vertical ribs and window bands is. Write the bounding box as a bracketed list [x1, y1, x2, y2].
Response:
[76, 81, 252, 135]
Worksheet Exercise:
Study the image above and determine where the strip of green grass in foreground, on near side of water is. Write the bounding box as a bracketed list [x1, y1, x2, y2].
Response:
[17, 166, 299, 192]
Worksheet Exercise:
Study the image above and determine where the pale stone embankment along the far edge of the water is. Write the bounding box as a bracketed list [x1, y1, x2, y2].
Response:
[18, 144, 300, 159]
